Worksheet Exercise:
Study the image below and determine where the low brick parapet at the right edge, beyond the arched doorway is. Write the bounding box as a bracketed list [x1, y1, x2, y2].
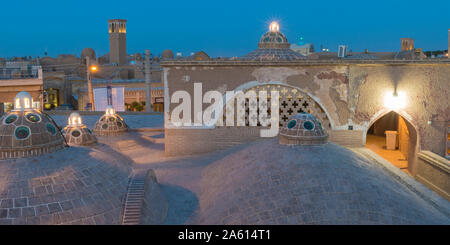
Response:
[415, 151, 450, 201]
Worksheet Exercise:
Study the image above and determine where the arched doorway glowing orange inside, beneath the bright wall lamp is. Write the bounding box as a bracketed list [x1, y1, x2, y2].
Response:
[366, 111, 418, 175]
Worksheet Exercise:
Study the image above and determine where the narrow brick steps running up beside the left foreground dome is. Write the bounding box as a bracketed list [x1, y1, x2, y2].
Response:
[122, 175, 145, 225]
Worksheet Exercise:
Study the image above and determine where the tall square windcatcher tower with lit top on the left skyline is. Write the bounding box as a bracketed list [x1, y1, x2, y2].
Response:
[108, 19, 127, 65]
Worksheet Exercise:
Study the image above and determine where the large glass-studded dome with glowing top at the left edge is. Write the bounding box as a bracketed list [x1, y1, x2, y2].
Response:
[0, 92, 64, 159]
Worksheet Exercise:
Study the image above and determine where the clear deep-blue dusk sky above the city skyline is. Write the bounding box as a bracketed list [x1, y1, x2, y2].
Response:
[0, 0, 450, 57]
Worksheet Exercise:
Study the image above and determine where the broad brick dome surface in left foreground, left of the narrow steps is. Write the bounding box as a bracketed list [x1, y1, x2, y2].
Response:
[0, 146, 131, 225]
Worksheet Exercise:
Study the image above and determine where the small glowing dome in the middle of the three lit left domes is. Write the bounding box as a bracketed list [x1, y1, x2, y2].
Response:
[64, 112, 97, 145]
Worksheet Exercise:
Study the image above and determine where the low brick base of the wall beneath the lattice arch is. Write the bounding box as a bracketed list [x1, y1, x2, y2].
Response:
[164, 127, 364, 156]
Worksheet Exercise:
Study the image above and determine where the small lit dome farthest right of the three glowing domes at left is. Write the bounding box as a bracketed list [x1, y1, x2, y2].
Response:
[93, 106, 128, 136]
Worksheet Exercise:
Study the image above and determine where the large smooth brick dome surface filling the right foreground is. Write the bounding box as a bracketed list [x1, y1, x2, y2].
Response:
[192, 139, 450, 224]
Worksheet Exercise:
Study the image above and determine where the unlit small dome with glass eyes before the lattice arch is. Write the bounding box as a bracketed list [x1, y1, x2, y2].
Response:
[280, 113, 328, 145]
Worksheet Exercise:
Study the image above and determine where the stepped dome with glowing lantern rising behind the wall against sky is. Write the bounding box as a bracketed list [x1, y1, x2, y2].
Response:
[242, 22, 306, 61]
